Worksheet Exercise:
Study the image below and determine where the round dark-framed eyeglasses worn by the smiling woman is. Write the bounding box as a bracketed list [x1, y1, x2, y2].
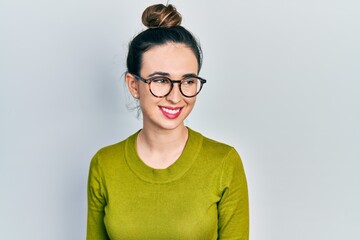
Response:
[132, 74, 206, 98]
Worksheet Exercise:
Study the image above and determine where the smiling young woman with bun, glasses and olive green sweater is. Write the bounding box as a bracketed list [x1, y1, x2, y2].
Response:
[87, 4, 249, 240]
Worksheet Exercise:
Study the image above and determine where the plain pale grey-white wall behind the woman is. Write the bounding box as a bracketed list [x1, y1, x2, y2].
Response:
[0, 0, 360, 240]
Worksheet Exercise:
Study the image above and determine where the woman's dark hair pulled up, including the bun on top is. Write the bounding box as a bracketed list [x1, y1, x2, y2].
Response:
[126, 4, 202, 75]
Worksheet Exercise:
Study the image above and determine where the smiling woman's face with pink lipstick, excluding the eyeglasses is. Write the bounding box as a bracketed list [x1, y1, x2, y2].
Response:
[127, 43, 198, 133]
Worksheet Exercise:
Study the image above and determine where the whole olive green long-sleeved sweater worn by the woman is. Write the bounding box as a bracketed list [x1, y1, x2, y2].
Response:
[87, 129, 249, 240]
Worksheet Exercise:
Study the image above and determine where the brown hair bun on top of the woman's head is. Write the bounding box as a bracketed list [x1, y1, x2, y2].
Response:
[141, 4, 182, 28]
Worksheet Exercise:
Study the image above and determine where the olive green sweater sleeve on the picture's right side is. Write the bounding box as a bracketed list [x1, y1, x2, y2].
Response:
[218, 149, 249, 240]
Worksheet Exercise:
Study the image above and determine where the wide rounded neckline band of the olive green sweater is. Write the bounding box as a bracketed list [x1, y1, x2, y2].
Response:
[125, 128, 203, 183]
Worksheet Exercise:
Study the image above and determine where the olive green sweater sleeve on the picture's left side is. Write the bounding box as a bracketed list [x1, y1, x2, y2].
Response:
[86, 154, 110, 240]
